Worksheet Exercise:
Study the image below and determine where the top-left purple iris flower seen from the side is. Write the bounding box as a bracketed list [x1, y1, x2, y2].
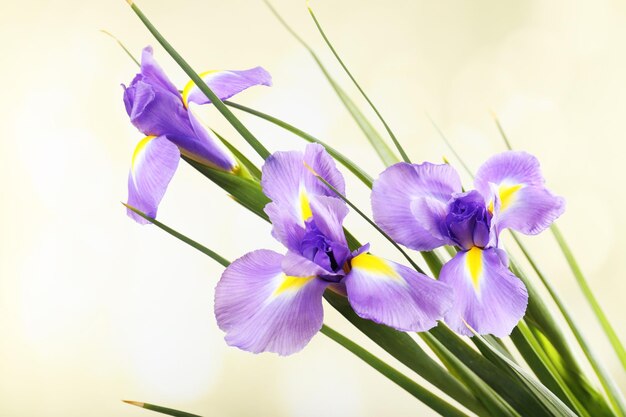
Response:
[124, 46, 271, 224]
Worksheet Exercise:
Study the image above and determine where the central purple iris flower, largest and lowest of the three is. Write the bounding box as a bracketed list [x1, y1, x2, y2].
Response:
[215, 144, 452, 355]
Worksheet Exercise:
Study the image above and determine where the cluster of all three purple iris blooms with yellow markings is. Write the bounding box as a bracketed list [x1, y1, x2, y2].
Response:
[124, 47, 565, 355]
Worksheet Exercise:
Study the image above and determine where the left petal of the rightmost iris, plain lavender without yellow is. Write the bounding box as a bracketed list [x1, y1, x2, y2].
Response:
[372, 162, 462, 250]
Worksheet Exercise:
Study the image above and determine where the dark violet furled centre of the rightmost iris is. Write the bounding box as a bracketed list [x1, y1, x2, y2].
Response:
[445, 191, 492, 249]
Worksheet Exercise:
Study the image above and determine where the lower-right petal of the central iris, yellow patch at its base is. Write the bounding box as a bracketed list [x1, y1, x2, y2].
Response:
[344, 253, 452, 332]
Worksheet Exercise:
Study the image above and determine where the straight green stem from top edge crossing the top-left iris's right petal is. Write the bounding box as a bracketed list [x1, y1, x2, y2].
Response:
[130, 2, 270, 159]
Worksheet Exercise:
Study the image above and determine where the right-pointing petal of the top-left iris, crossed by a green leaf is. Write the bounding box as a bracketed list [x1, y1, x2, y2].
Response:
[183, 67, 272, 104]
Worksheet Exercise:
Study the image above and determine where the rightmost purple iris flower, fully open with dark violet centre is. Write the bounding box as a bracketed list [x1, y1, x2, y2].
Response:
[372, 151, 565, 337]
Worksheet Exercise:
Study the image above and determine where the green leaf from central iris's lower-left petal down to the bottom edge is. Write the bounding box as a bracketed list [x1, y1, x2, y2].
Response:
[321, 325, 467, 417]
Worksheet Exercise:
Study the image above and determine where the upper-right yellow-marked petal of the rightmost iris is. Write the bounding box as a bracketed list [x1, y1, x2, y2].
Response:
[474, 151, 565, 235]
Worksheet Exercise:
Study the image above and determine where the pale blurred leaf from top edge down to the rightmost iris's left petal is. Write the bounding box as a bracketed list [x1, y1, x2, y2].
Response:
[264, 0, 400, 166]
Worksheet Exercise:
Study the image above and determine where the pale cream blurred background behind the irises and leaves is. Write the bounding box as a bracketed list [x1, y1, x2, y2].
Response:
[0, 0, 626, 417]
